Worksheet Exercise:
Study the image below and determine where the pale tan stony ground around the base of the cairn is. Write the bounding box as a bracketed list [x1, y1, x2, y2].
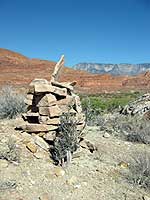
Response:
[0, 118, 150, 200]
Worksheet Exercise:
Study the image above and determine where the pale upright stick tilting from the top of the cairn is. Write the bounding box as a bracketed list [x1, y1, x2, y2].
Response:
[51, 55, 65, 82]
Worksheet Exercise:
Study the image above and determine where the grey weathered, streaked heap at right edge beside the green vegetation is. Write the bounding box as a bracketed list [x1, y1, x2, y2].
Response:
[121, 93, 150, 116]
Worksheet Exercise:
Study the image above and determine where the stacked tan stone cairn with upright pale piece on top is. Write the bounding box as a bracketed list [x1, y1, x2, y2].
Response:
[23, 56, 85, 160]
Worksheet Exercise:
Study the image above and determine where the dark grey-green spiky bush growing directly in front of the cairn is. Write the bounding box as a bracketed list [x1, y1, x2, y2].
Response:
[51, 113, 80, 166]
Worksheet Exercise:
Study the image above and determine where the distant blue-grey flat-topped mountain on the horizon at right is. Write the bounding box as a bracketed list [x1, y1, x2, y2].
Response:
[72, 63, 150, 76]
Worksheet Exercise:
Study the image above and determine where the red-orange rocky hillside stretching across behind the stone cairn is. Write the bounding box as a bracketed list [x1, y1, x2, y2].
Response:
[0, 49, 150, 94]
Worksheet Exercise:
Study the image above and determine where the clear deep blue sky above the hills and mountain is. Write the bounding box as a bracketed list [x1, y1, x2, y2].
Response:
[0, 0, 150, 66]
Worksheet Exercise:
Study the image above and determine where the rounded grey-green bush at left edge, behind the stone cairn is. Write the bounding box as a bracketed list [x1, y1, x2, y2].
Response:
[0, 86, 26, 119]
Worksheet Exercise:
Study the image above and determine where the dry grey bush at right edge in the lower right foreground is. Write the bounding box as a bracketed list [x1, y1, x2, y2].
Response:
[126, 151, 150, 189]
